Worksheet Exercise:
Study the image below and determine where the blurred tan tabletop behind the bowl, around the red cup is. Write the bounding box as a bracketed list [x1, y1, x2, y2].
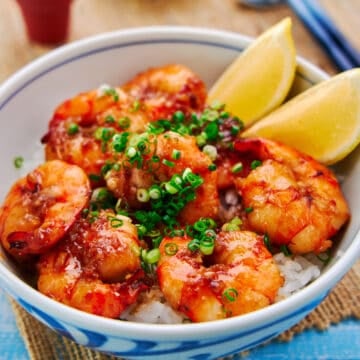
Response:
[0, 0, 360, 81]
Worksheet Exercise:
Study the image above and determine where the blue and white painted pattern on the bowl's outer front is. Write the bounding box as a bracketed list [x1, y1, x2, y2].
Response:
[17, 296, 324, 360]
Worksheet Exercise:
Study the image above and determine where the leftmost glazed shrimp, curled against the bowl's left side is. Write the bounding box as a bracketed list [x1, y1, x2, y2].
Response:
[0, 160, 90, 258]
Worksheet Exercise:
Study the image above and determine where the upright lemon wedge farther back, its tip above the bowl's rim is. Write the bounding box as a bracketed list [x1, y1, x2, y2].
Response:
[208, 18, 296, 126]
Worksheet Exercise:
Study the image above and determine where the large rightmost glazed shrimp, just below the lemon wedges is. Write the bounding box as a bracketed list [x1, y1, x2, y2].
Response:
[234, 138, 349, 254]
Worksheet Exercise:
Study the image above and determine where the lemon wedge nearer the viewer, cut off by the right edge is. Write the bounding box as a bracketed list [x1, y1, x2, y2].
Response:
[241, 68, 360, 165]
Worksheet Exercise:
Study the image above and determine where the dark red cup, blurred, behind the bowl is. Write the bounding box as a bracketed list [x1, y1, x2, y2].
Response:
[17, 0, 72, 45]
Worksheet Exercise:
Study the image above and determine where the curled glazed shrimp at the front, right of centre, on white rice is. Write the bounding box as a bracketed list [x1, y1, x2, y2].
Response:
[157, 231, 283, 322]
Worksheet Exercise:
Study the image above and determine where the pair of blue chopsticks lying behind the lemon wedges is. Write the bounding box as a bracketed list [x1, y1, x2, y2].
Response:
[287, 0, 360, 71]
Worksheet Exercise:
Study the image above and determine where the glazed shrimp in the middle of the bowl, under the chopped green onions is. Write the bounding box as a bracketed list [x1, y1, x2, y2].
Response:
[105, 132, 219, 223]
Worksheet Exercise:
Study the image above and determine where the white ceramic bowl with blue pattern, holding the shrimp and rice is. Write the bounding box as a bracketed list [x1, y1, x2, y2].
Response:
[0, 27, 360, 360]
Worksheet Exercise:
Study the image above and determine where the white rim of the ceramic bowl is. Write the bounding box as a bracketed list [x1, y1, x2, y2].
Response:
[0, 26, 360, 340]
